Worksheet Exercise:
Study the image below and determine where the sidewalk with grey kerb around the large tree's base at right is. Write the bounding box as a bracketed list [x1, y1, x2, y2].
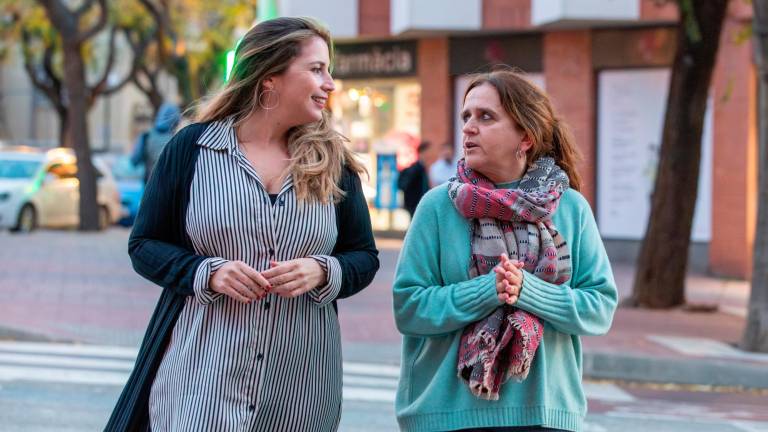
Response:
[583, 264, 768, 389]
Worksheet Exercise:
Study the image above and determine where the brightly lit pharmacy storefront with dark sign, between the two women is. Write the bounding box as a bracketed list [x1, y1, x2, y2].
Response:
[330, 41, 421, 230]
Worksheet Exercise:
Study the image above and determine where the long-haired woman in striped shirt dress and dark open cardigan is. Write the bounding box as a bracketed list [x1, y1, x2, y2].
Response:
[106, 18, 379, 432]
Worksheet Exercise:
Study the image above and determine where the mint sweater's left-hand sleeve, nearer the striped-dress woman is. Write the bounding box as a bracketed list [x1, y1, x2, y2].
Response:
[393, 190, 500, 337]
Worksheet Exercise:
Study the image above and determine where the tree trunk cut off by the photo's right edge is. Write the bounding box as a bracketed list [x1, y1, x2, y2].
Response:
[741, 0, 768, 353]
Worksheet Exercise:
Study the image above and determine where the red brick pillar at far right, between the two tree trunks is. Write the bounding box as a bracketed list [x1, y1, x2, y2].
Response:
[709, 13, 757, 278]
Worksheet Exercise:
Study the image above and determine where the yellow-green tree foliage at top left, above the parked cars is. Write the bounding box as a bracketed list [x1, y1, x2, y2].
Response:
[0, 0, 256, 105]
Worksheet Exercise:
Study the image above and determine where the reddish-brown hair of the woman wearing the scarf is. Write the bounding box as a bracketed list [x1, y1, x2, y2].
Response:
[464, 69, 581, 190]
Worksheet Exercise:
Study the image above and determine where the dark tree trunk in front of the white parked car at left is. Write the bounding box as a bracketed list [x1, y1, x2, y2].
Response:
[63, 41, 99, 231]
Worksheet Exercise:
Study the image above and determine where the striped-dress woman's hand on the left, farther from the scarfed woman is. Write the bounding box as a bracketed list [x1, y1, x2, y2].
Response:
[208, 261, 272, 303]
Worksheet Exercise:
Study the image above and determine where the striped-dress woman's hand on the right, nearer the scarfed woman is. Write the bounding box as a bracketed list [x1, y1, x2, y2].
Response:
[261, 258, 327, 298]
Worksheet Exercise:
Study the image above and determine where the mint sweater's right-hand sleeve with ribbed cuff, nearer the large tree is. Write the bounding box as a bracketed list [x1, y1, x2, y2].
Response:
[516, 202, 618, 336]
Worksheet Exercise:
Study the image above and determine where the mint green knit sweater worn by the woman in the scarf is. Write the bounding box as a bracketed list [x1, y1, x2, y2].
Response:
[393, 184, 617, 431]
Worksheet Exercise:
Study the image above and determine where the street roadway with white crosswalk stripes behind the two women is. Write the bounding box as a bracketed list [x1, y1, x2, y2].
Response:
[0, 342, 768, 432]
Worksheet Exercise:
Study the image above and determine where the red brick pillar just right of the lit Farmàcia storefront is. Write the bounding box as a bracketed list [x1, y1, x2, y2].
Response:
[418, 38, 453, 164]
